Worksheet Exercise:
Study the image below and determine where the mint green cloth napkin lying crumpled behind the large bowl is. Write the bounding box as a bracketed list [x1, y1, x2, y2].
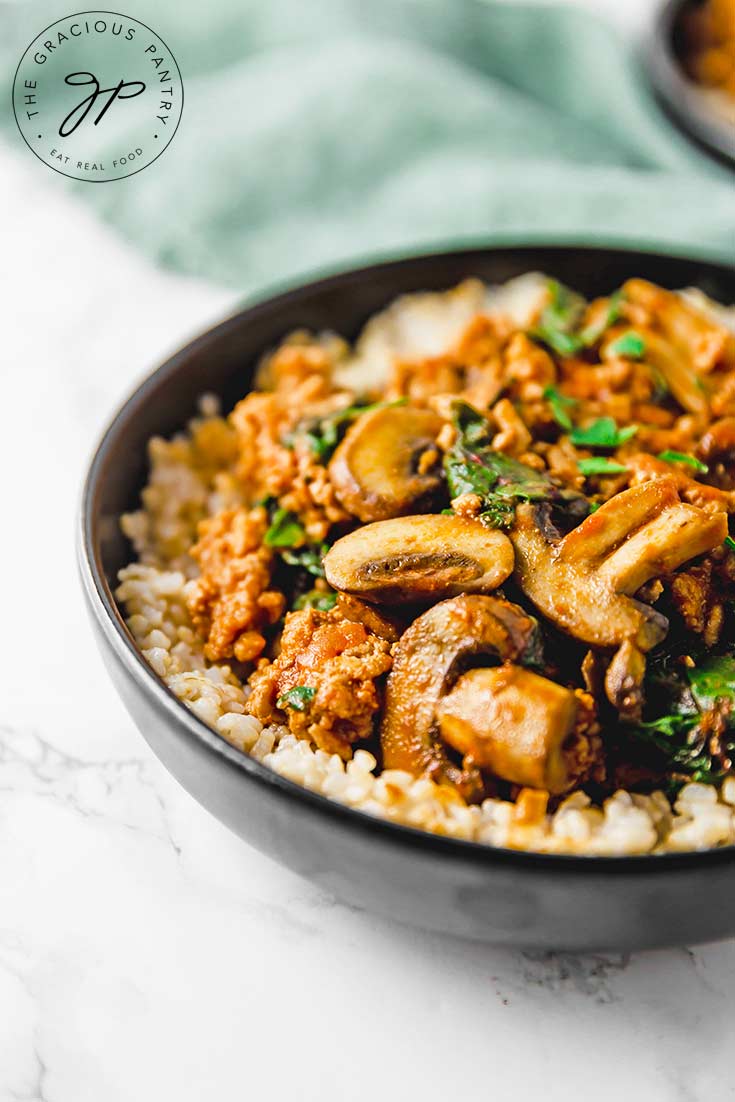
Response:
[0, 0, 735, 291]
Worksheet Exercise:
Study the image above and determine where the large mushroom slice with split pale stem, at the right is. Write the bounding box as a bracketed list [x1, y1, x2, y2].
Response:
[510, 478, 727, 651]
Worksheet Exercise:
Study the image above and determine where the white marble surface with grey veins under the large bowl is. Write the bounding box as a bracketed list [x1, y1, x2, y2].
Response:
[0, 17, 735, 1102]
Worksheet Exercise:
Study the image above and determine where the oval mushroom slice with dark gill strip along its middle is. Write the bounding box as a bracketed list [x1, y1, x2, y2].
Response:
[324, 514, 514, 603]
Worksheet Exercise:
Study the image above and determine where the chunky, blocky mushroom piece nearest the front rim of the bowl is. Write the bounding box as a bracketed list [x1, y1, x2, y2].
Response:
[436, 665, 577, 795]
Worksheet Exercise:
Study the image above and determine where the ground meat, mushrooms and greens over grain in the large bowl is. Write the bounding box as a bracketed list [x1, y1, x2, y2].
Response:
[117, 274, 735, 854]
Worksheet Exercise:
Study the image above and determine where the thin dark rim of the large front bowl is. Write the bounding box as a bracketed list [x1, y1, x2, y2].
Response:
[76, 234, 735, 875]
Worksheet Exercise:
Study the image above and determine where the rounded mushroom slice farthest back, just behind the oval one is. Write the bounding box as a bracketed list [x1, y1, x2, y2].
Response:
[328, 406, 442, 521]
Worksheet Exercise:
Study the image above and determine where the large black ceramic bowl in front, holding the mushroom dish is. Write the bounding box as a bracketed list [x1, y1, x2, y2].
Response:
[80, 247, 735, 950]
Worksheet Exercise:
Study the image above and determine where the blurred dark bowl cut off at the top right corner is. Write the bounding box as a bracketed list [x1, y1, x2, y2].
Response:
[646, 0, 735, 168]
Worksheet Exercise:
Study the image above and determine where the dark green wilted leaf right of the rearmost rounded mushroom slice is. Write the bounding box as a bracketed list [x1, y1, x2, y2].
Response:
[444, 401, 587, 528]
